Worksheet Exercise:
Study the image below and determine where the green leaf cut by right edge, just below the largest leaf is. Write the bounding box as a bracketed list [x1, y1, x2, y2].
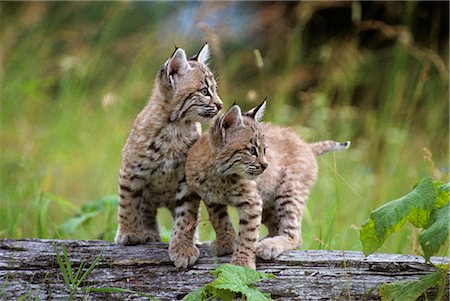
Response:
[419, 203, 450, 260]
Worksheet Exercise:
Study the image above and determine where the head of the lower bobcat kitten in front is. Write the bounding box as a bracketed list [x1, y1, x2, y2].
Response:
[210, 102, 268, 180]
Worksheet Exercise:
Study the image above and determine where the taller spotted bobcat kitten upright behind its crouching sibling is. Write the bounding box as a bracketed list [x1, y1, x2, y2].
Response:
[115, 44, 222, 253]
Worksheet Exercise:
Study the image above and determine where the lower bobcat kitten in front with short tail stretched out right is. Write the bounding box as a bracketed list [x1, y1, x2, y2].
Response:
[181, 102, 349, 269]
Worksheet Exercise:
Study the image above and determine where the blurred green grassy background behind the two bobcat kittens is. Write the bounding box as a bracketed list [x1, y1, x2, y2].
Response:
[0, 1, 449, 253]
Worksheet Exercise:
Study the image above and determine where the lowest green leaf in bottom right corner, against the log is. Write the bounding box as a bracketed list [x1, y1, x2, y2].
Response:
[379, 271, 446, 301]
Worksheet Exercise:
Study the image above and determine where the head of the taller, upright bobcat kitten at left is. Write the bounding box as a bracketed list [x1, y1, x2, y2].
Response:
[158, 44, 223, 123]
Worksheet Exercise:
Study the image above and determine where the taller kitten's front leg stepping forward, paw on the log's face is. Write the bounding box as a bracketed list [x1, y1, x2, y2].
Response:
[169, 194, 200, 269]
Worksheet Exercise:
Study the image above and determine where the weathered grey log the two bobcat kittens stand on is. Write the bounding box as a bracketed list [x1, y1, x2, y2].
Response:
[0, 239, 448, 300]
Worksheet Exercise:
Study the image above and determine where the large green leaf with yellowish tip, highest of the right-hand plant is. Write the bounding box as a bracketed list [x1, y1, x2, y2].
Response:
[360, 178, 437, 256]
